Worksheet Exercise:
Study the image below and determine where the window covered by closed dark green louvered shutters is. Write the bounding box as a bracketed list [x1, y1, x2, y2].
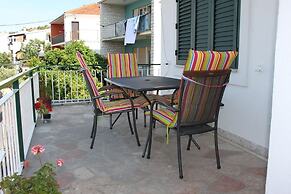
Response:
[176, 0, 240, 68]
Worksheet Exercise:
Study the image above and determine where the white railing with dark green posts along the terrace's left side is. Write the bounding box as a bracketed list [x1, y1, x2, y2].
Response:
[0, 68, 39, 188]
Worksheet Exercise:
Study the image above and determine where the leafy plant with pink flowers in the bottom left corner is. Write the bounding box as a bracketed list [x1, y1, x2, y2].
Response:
[0, 145, 64, 194]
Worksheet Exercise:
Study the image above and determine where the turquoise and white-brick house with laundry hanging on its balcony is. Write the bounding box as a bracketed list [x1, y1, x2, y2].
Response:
[99, 0, 153, 68]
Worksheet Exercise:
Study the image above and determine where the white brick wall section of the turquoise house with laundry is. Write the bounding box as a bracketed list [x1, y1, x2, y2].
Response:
[100, 3, 125, 56]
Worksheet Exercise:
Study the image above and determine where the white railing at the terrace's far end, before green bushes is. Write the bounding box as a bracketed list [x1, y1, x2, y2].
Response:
[40, 64, 153, 105]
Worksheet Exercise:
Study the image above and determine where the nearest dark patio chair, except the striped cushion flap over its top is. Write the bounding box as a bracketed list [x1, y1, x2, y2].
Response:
[143, 70, 231, 179]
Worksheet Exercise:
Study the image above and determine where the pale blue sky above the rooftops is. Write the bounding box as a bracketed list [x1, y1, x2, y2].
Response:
[0, 0, 97, 32]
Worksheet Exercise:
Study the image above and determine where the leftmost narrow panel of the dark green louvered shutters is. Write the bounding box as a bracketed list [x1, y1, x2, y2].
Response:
[177, 0, 192, 64]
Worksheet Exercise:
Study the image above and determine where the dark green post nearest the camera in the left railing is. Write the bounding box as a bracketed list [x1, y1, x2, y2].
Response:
[13, 80, 24, 162]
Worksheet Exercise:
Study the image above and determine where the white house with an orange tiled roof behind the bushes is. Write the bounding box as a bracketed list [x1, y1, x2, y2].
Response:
[50, 4, 100, 53]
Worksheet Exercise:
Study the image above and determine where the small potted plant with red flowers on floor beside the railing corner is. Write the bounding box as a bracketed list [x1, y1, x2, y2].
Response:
[34, 98, 52, 121]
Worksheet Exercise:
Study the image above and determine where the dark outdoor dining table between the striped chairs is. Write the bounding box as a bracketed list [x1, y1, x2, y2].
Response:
[105, 76, 180, 103]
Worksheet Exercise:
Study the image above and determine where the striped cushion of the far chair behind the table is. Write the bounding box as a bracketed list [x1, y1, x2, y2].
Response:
[107, 53, 138, 100]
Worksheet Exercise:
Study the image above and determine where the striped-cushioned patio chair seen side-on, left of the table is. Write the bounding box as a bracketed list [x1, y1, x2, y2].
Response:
[76, 52, 146, 149]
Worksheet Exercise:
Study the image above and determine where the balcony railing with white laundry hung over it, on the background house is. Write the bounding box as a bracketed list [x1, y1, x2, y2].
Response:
[103, 13, 151, 40]
